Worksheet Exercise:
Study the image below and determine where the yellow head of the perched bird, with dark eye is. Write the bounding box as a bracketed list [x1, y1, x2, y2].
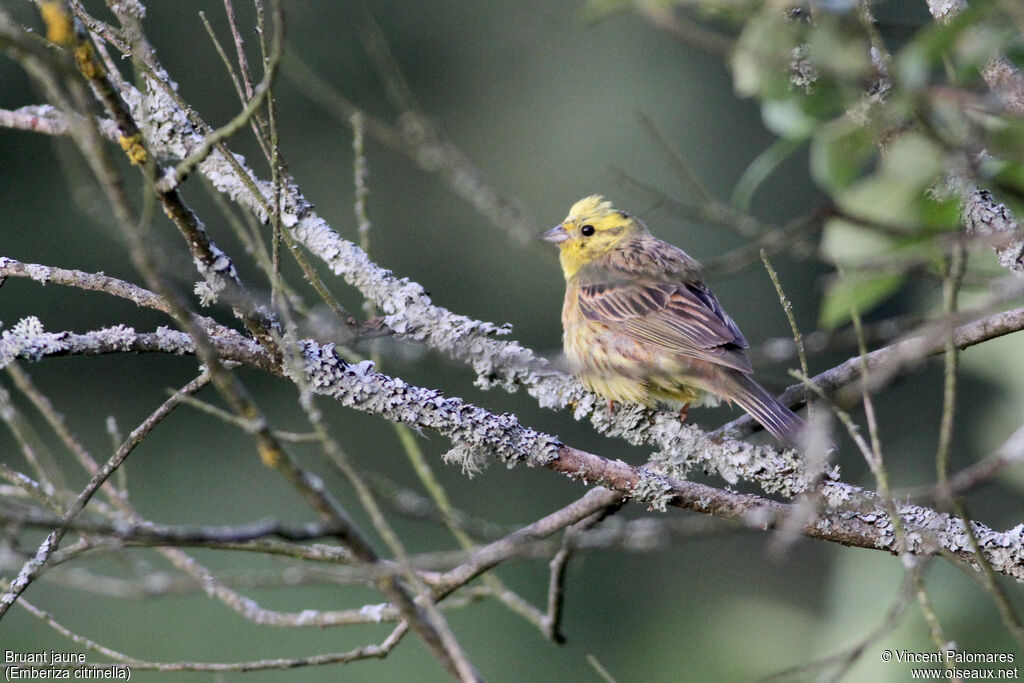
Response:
[541, 195, 646, 280]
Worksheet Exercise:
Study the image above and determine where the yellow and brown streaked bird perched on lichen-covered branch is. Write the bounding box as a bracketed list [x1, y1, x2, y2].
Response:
[540, 195, 806, 447]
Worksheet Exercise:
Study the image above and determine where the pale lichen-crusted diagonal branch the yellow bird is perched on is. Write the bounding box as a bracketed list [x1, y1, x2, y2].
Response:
[0, 93, 806, 495]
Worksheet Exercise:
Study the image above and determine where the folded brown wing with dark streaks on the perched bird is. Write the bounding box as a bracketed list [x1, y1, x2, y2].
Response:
[579, 281, 752, 373]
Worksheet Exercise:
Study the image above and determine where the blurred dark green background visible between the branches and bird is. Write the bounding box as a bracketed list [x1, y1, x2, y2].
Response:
[0, 0, 1024, 681]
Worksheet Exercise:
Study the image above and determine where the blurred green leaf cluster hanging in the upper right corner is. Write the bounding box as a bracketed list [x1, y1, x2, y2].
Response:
[731, 2, 1024, 328]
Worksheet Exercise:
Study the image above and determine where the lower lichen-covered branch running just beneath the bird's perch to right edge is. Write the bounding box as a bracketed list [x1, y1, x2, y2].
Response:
[0, 319, 1024, 581]
